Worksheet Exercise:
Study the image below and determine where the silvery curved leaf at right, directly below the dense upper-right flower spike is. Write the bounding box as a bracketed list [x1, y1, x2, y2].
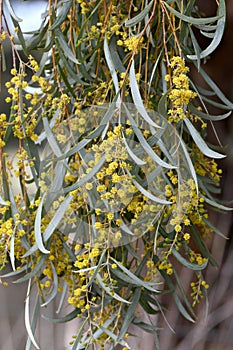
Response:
[184, 118, 225, 159]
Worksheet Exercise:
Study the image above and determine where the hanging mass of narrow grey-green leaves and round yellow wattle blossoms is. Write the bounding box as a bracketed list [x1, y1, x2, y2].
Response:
[0, 0, 232, 350]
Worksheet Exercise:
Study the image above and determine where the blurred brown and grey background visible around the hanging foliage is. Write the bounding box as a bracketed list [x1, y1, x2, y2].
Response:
[0, 0, 233, 350]
